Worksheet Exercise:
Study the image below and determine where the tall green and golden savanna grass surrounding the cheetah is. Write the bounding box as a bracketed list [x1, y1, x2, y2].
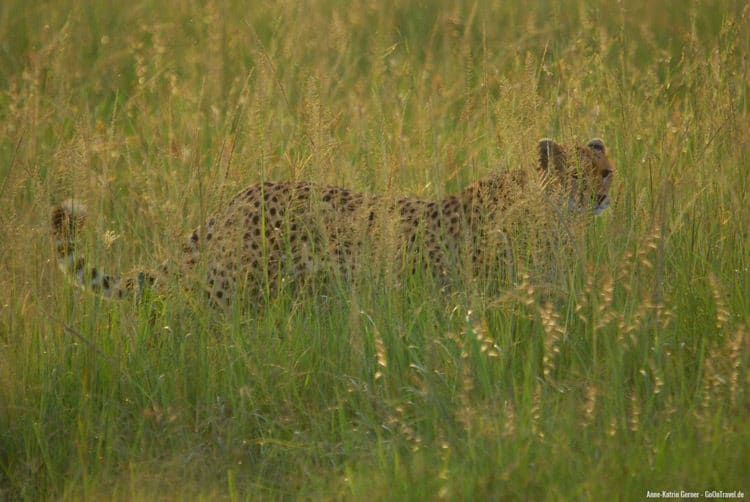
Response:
[0, 0, 750, 500]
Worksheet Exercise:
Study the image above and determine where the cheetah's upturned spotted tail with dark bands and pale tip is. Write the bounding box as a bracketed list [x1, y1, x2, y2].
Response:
[52, 199, 153, 298]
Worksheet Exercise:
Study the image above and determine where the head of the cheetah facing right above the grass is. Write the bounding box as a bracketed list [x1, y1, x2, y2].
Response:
[539, 138, 614, 214]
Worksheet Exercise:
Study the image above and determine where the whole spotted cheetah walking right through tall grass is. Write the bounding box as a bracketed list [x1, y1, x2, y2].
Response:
[52, 138, 614, 308]
